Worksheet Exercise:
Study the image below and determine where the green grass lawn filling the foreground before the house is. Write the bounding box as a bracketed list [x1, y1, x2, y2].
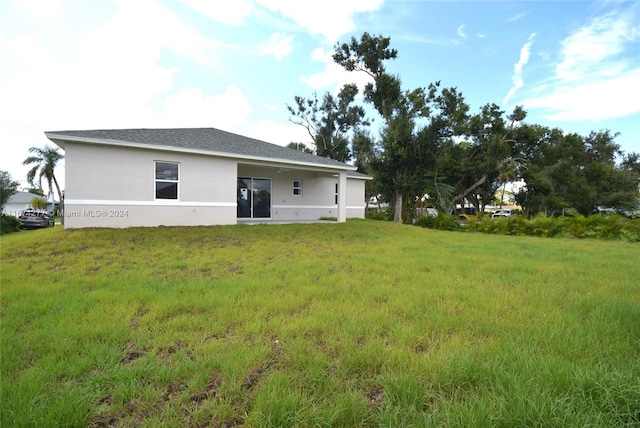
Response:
[0, 220, 640, 427]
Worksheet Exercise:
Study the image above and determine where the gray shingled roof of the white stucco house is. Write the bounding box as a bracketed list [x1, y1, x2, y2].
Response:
[45, 128, 353, 169]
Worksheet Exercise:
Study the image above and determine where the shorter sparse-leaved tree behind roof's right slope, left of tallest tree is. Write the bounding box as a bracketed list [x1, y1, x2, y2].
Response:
[287, 84, 368, 162]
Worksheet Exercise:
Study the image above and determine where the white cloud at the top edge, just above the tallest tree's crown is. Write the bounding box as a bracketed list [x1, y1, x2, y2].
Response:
[257, 0, 383, 44]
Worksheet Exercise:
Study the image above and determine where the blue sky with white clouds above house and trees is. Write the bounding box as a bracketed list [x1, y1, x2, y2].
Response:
[0, 0, 640, 186]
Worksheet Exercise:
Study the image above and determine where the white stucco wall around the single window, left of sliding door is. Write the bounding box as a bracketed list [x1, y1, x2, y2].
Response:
[65, 142, 237, 228]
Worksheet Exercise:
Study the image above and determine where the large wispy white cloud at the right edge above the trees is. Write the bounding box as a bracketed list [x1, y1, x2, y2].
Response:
[521, 3, 640, 122]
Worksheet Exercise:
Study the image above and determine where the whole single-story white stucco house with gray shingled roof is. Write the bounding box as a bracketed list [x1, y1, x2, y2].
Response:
[45, 128, 371, 228]
